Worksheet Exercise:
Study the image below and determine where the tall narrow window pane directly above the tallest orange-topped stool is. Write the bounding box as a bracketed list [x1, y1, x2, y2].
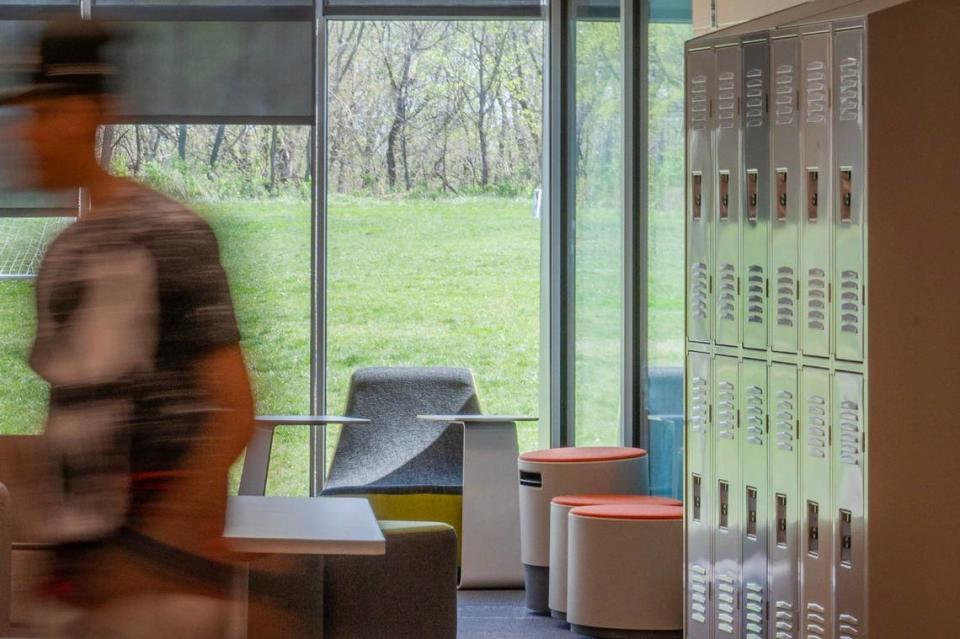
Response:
[575, 12, 623, 446]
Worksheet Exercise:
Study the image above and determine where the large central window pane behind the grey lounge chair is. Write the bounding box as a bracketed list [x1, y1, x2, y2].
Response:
[327, 21, 543, 459]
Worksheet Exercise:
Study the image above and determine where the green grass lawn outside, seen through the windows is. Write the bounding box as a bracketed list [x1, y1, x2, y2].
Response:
[0, 197, 683, 494]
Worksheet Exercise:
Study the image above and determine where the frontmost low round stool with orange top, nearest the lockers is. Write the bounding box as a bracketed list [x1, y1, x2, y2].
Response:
[567, 504, 683, 639]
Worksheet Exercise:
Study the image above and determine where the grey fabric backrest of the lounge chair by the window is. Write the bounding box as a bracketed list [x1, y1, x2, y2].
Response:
[324, 367, 480, 494]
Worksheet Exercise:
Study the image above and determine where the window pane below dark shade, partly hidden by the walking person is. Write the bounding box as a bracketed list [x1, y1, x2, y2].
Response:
[99, 125, 312, 495]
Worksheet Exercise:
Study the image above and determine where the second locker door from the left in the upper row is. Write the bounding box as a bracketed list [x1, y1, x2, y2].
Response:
[714, 45, 742, 346]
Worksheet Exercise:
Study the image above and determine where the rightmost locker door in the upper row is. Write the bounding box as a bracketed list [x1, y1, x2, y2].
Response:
[833, 29, 866, 361]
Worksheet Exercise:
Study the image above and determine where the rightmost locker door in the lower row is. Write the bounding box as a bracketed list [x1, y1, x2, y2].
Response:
[833, 373, 867, 639]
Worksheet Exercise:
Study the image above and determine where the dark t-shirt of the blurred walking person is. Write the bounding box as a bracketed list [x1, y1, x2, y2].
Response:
[30, 184, 240, 541]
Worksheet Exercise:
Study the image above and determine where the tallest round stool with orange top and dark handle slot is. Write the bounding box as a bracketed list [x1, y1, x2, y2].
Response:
[518, 446, 648, 614]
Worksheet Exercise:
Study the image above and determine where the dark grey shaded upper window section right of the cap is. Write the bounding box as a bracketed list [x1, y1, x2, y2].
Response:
[108, 21, 313, 122]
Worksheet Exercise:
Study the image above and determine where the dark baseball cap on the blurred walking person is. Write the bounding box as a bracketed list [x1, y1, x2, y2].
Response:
[0, 18, 117, 106]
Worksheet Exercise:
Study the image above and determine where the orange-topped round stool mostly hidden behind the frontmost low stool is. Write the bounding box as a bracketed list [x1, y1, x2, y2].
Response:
[550, 494, 683, 619]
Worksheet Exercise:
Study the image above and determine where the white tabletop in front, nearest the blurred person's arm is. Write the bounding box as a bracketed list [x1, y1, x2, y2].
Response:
[224, 496, 386, 555]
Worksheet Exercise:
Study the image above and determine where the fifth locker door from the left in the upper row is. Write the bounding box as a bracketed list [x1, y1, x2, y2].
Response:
[800, 33, 833, 357]
